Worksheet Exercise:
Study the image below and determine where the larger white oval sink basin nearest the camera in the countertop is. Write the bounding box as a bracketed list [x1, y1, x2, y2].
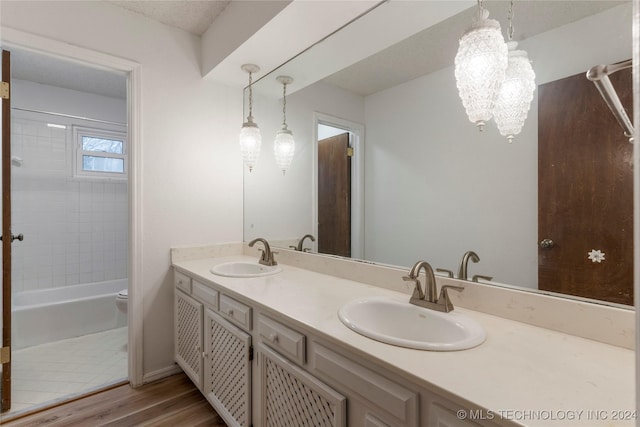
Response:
[338, 297, 487, 351]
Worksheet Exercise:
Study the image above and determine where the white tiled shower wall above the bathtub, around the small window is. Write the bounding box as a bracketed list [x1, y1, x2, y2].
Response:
[11, 115, 128, 292]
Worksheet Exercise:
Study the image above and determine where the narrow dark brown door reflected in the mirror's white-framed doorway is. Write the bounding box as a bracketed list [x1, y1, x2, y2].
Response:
[318, 132, 351, 257]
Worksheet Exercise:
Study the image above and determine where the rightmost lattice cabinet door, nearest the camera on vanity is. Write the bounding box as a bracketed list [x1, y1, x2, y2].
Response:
[259, 347, 347, 427]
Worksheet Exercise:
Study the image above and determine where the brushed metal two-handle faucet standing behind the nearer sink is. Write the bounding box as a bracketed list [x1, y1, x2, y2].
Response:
[402, 261, 464, 313]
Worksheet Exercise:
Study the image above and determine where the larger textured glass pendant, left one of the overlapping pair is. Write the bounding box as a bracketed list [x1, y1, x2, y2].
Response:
[455, 0, 507, 130]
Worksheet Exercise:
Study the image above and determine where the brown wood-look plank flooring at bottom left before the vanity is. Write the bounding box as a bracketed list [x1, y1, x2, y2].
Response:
[0, 373, 227, 427]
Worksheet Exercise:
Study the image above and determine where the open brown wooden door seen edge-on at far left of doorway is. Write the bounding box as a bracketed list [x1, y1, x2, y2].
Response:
[0, 50, 13, 412]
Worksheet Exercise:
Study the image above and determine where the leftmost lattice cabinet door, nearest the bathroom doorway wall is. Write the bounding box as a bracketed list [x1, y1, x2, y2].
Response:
[174, 289, 203, 388]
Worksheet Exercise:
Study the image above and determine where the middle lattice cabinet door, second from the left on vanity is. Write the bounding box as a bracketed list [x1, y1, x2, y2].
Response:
[203, 309, 252, 427]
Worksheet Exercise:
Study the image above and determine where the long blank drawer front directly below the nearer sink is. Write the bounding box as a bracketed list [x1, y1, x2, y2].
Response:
[310, 345, 419, 427]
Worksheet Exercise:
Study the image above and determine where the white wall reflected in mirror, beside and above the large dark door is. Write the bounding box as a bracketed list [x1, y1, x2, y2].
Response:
[365, 4, 631, 288]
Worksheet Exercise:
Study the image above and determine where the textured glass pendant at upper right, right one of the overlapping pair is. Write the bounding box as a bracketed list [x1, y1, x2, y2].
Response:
[493, 0, 536, 143]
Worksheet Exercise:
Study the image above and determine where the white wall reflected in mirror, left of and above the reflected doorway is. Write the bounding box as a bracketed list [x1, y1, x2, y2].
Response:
[244, 78, 364, 246]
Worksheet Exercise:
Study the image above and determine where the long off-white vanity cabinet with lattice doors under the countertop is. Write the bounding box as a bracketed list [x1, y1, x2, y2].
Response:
[175, 270, 509, 427]
